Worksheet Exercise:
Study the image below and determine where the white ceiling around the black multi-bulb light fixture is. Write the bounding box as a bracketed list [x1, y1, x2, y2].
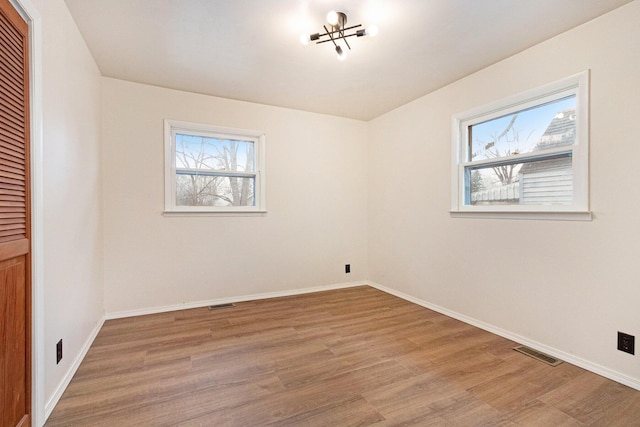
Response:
[65, 0, 631, 120]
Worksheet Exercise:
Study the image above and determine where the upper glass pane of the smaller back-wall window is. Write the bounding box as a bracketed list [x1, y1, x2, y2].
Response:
[175, 133, 255, 173]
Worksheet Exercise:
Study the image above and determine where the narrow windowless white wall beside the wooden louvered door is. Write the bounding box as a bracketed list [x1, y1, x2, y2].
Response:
[34, 0, 104, 416]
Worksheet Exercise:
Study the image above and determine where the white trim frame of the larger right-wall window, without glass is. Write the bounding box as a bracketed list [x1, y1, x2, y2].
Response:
[450, 70, 591, 221]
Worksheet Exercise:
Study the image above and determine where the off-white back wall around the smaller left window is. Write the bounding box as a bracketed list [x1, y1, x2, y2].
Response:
[102, 78, 367, 315]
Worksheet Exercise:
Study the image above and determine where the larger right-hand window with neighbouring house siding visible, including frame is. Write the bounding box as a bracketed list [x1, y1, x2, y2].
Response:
[451, 72, 590, 219]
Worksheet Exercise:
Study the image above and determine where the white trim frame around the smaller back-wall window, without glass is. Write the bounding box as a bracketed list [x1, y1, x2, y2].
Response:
[164, 119, 267, 216]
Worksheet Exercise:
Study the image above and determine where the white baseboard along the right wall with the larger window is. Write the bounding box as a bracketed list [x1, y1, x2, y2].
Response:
[367, 281, 640, 390]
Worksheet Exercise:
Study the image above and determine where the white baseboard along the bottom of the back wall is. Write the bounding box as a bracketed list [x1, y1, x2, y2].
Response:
[106, 281, 368, 320]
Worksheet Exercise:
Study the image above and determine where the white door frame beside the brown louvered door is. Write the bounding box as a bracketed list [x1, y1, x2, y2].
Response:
[9, 0, 46, 426]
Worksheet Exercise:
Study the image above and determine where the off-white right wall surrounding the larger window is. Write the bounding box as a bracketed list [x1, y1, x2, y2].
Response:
[368, 1, 640, 385]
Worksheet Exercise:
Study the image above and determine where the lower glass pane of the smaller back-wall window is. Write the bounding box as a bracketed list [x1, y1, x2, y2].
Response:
[176, 173, 255, 206]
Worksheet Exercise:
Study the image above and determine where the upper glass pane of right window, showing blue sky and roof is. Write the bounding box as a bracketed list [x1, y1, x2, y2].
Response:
[467, 95, 576, 161]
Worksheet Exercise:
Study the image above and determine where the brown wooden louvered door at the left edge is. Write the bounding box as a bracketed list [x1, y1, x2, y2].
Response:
[0, 0, 31, 427]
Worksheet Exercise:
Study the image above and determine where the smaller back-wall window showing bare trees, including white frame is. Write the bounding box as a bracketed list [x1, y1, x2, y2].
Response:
[164, 120, 265, 212]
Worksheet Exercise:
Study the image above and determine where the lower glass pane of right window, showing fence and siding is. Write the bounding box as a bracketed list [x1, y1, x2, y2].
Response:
[466, 153, 573, 205]
